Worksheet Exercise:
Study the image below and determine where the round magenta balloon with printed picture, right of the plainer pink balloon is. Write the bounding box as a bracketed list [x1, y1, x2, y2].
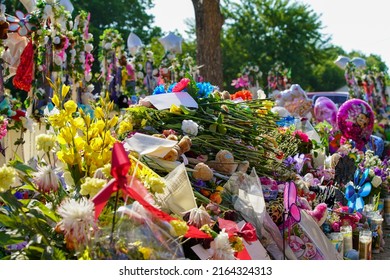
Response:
[337, 98, 374, 150]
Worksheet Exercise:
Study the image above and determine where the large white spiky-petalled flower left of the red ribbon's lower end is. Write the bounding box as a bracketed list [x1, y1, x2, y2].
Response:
[57, 197, 95, 249]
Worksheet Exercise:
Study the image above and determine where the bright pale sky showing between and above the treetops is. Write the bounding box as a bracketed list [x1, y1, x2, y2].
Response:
[151, 0, 390, 67]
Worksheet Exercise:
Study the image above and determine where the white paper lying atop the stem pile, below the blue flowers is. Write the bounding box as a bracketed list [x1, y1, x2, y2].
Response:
[145, 91, 198, 110]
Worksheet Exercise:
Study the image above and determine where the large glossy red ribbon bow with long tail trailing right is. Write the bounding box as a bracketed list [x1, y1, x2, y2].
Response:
[92, 142, 211, 238]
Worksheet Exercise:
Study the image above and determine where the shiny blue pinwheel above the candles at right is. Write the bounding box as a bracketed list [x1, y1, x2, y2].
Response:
[345, 168, 372, 213]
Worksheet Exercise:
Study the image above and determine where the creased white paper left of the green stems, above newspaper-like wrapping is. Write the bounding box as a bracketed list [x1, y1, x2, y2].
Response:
[124, 133, 177, 158]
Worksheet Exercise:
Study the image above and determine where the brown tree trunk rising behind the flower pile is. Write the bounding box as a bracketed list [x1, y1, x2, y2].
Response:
[192, 0, 224, 88]
